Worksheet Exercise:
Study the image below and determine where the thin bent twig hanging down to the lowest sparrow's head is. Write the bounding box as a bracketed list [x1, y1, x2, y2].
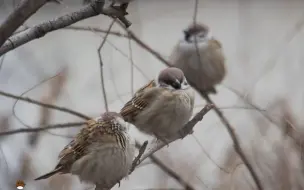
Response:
[97, 19, 116, 111]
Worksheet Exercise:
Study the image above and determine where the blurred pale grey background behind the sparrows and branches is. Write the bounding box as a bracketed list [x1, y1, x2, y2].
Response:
[0, 0, 304, 190]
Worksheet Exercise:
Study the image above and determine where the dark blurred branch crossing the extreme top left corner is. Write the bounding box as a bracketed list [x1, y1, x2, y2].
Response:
[0, 0, 48, 47]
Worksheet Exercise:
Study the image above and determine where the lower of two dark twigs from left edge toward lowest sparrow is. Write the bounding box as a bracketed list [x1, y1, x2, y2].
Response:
[0, 122, 86, 136]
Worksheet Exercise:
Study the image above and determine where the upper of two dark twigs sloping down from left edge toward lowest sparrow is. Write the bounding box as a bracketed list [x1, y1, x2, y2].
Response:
[0, 91, 91, 120]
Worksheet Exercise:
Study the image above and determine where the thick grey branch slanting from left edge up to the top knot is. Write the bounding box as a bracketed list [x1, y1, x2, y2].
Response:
[0, 0, 131, 56]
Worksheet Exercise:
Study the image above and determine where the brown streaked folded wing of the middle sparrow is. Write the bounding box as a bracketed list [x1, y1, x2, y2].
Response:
[120, 80, 156, 123]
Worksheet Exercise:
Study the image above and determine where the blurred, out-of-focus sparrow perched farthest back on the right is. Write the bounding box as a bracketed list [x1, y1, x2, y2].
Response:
[169, 23, 226, 94]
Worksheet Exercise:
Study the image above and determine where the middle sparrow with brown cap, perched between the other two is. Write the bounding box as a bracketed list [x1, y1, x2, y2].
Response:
[120, 67, 194, 144]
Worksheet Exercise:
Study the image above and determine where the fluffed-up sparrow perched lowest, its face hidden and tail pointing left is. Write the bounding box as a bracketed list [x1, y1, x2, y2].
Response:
[35, 112, 135, 190]
